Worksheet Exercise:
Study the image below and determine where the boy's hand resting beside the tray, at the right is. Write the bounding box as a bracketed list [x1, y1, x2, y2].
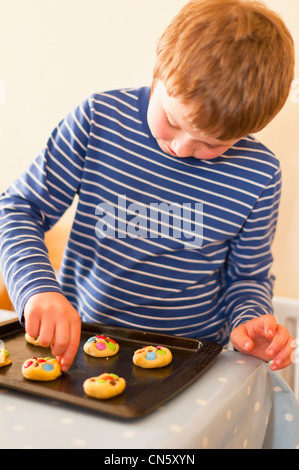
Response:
[230, 315, 295, 370]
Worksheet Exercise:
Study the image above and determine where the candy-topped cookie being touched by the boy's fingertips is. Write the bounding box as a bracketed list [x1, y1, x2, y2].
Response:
[22, 357, 61, 382]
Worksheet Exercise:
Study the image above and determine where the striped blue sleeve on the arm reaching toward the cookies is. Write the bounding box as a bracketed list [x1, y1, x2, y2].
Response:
[0, 100, 90, 319]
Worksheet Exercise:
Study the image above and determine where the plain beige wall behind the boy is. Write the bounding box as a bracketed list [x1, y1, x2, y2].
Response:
[0, 0, 299, 298]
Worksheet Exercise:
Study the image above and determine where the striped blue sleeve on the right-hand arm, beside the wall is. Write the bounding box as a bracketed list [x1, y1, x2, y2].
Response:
[224, 163, 281, 330]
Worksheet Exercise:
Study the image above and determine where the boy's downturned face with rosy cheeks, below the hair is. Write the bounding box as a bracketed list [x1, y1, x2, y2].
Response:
[147, 81, 238, 160]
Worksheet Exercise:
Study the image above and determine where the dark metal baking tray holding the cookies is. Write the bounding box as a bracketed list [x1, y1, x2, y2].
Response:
[0, 320, 222, 419]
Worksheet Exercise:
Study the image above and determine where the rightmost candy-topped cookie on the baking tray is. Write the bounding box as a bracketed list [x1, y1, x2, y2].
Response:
[133, 346, 172, 369]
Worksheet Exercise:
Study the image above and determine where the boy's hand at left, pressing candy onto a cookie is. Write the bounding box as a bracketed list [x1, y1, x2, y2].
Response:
[24, 292, 81, 372]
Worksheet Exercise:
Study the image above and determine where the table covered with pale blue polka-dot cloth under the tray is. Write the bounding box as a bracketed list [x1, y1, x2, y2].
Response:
[0, 311, 299, 450]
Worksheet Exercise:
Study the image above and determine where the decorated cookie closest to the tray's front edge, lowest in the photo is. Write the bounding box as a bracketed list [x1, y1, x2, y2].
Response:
[83, 373, 126, 399]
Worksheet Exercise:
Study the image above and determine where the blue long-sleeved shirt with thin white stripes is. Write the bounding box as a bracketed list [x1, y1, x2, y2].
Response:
[0, 87, 281, 344]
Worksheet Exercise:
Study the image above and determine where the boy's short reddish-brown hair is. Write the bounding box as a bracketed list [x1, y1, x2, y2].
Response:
[153, 0, 294, 140]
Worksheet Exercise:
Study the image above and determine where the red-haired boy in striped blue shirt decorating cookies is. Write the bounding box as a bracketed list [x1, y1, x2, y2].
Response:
[1, 0, 294, 370]
